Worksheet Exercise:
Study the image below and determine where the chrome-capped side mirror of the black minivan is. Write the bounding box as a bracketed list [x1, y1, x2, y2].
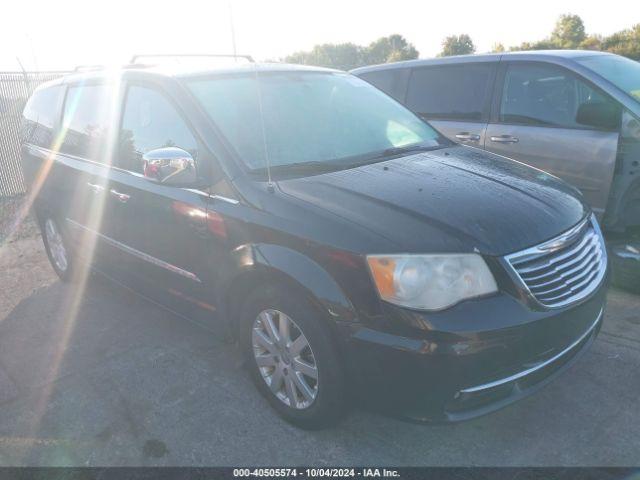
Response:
[142, 147, 198, 187]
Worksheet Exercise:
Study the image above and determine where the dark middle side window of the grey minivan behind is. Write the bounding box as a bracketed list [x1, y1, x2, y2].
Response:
[407, 63, 494, 121]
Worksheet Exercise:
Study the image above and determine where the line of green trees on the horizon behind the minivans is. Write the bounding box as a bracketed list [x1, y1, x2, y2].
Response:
[283, 14, 640, 70]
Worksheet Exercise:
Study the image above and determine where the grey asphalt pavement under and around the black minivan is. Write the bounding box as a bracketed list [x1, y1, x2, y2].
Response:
[0, 256, 640, 466]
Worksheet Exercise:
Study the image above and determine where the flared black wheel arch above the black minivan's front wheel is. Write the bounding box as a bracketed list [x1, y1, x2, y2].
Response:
[219, 243, 356, 322]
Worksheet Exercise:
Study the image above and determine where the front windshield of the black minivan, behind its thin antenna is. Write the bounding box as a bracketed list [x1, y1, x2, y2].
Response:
[187, 71, 450, 171]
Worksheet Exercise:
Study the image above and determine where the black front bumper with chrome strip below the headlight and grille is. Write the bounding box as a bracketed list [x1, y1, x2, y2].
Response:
[344, 282, 607, 422]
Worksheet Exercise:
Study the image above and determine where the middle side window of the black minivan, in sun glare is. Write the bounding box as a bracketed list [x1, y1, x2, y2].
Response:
[60, 85, 115, 163]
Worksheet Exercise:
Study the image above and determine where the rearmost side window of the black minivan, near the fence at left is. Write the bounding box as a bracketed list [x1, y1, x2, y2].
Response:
[22, 86, 62, 148]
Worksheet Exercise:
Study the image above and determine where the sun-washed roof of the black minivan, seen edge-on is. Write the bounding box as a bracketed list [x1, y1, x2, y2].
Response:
[43, 63, 340, 86]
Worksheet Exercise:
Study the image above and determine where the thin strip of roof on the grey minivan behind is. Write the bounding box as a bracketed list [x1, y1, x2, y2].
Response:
[350, 50, 613, 75]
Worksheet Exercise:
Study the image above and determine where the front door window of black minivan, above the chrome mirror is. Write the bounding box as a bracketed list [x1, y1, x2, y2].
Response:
[118, 86, 198, 173]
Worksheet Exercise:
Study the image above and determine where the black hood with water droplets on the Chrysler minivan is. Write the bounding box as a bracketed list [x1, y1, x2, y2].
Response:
[278, 146, 588, 256]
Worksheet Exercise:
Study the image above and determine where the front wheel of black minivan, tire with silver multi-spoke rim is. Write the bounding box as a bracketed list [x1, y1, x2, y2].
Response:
[239, 285, 346, 430]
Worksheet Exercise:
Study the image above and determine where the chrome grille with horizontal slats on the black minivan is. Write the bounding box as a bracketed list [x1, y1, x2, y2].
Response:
[505, 217, 607, 307]
